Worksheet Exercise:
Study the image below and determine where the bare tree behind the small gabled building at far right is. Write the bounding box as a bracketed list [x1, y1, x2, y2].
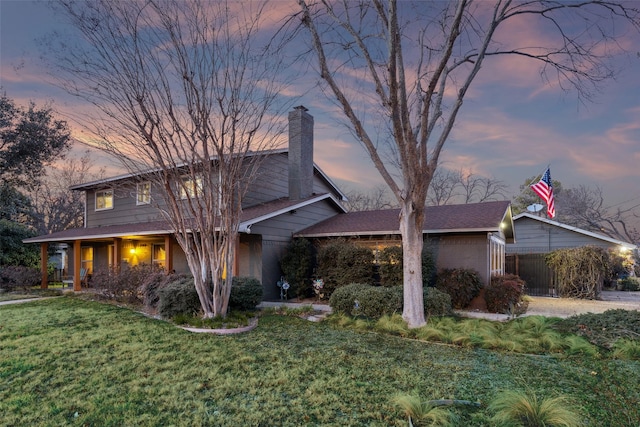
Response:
[558, 185, 640, 243]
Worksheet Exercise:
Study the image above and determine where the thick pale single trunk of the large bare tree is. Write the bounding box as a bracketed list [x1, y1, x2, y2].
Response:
[400, 201, 427, 328]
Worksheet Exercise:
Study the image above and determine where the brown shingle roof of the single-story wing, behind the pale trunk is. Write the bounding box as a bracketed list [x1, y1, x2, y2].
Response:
[296, 201, 513, 239]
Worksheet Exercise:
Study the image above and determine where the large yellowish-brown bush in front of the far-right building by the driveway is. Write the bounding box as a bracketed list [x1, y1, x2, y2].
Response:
[545, 246, 610, 299]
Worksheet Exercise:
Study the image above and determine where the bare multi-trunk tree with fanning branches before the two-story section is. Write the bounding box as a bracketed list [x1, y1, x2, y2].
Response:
[52, 0, 288, 317]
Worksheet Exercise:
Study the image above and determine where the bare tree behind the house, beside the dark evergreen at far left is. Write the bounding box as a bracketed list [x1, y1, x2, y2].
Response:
[27, 151, 105, 234]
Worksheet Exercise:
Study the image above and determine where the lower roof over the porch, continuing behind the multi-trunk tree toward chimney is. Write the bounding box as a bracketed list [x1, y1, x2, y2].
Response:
[23, 193, 345, 243]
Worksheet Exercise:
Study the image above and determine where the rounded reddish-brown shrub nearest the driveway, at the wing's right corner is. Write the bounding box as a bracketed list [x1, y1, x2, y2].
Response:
[484, 274, 529, 315]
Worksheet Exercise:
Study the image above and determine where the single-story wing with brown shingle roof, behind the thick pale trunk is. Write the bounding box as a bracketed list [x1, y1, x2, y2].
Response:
[296, 201, 515, 284]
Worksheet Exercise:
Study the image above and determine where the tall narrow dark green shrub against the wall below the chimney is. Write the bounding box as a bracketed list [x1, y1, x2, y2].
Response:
[280, 238, 313, 298]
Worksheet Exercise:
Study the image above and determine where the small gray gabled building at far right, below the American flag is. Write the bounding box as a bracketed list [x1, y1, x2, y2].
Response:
[506, 212, 638, 296]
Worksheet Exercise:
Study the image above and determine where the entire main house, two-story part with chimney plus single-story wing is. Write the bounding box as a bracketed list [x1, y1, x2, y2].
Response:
[24, 106, 514, 299]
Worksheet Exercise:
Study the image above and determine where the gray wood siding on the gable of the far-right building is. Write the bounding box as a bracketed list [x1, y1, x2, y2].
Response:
[507, 217, 616, 254]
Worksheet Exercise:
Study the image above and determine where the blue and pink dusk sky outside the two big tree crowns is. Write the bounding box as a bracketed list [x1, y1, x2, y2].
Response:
[0, 0, 640, 216]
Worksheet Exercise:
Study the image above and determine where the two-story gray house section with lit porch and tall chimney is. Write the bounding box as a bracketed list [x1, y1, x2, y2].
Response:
[25, 106, 346, 299]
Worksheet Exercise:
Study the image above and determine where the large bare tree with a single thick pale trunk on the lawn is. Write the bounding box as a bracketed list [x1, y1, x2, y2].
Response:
[298, 0, 639, 327]
